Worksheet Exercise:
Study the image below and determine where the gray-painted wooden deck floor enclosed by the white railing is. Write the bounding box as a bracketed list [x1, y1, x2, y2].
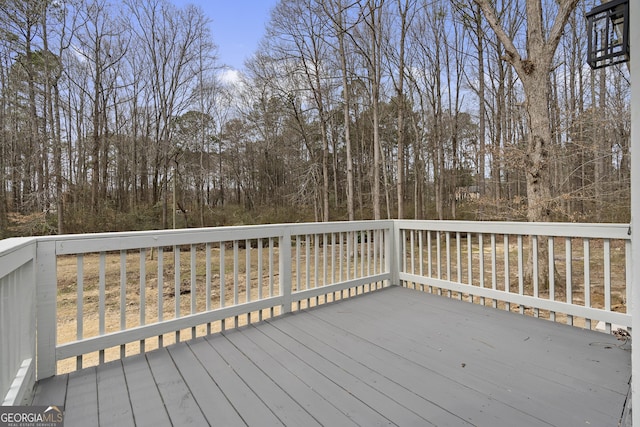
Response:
[34, 287, 631, 427]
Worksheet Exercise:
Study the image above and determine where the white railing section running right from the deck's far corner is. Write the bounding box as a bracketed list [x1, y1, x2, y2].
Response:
[395, 221, 631, 332]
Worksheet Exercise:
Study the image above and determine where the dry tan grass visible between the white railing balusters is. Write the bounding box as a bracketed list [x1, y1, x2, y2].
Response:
[57, 236, 626, 372]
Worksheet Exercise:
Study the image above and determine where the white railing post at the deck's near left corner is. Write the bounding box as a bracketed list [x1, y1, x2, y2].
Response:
[36, 240, 58, 380]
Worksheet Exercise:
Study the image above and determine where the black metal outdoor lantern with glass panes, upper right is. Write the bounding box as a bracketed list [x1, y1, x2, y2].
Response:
[587, 0, 629, 69]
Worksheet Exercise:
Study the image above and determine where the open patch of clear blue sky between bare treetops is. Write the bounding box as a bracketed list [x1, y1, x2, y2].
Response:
[172, 0, 278, 70]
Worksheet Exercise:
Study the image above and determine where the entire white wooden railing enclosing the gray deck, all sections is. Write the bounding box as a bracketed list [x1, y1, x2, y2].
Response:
[0, 221, 631, 403]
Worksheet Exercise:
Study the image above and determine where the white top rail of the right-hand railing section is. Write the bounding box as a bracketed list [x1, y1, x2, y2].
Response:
[395, 220, 631, 240]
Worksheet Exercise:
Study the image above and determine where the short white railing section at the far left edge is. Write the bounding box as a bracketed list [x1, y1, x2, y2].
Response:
[0, 239, 36, 405]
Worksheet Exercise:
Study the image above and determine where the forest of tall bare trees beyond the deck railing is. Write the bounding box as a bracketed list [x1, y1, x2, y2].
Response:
[0, 0, 630, 238]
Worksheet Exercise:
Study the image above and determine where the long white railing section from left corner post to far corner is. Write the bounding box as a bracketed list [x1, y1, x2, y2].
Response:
[38, 221, 393, 378]
